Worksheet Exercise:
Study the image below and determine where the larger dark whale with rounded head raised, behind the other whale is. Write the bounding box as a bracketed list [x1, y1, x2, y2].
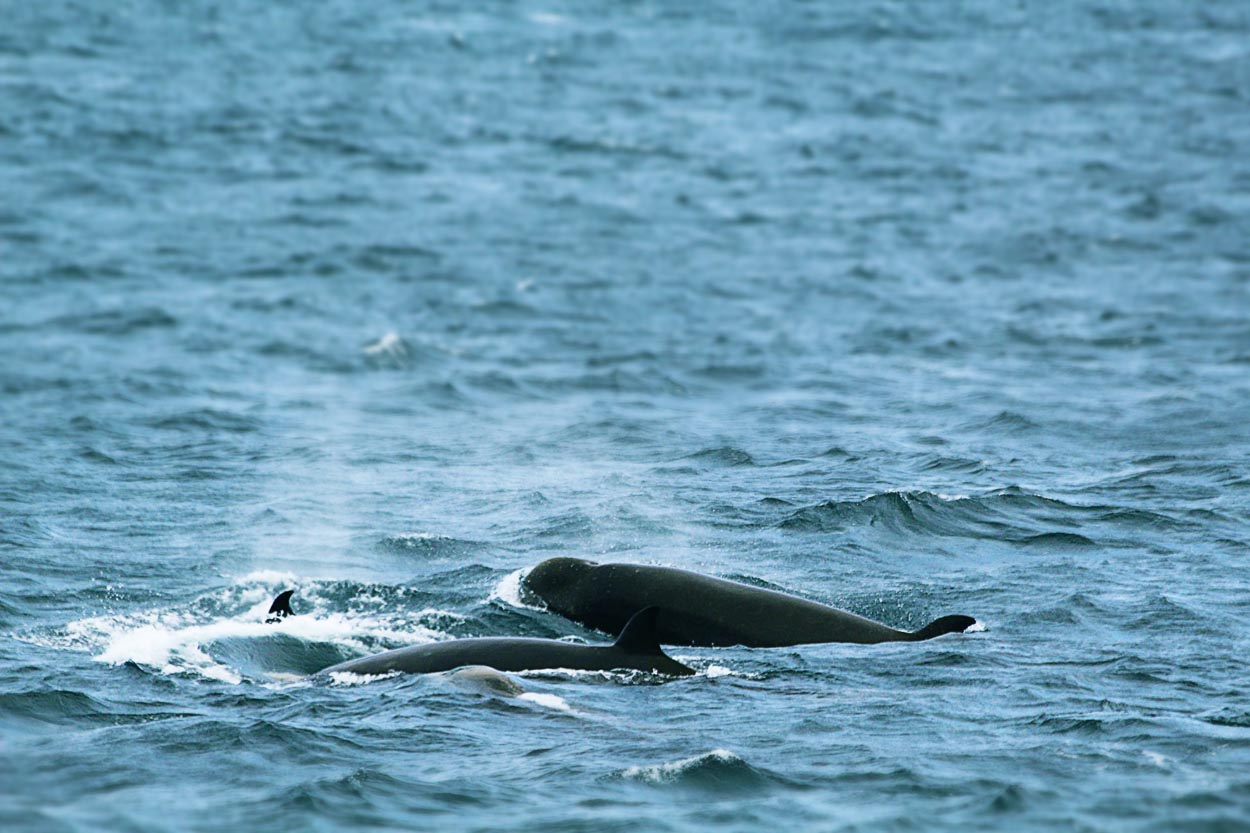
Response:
[521, 558, 976, 648]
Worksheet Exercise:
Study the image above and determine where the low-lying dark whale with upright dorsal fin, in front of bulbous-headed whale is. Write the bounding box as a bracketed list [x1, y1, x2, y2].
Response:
[308, 597, 695, 677]
